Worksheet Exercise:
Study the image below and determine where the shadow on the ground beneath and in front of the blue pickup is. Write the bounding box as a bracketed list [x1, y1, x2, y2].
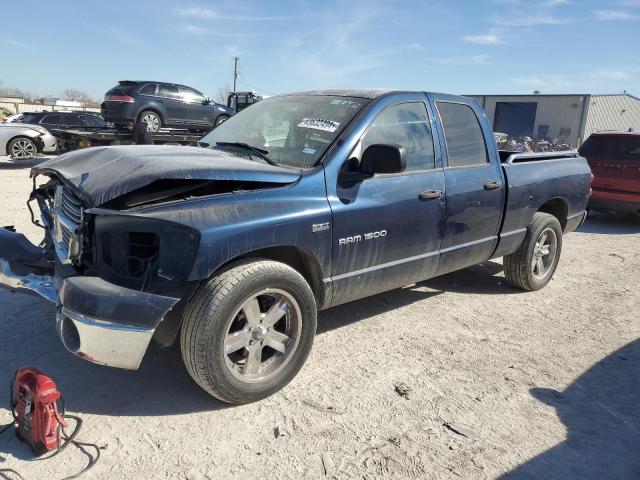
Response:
[0, 262, 513, 423]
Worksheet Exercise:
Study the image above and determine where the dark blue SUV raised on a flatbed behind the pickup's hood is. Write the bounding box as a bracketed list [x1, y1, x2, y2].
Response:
[101, 80, 235, 132]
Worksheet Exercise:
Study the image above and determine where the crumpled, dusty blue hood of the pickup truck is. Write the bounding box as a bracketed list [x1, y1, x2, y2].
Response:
[31, 145, 300, 207]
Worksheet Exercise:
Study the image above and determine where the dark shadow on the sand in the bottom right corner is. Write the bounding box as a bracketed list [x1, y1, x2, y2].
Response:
[501, 339, 640, 480]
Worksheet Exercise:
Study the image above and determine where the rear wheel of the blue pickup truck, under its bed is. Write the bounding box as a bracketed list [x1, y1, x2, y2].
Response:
[504, 212, 562, 291]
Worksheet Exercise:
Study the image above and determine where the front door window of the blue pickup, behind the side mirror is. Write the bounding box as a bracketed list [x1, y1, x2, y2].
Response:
[362, 102, 435, 172]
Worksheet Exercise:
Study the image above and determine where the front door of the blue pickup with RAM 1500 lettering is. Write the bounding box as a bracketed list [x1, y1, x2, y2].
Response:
[329, 98, 444, 304]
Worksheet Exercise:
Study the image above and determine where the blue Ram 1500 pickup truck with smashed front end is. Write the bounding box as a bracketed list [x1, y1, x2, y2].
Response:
[0, 90, 591, 403]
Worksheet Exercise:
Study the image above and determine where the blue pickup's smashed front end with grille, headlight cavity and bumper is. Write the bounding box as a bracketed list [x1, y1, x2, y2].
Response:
[0, 178, 182, 369]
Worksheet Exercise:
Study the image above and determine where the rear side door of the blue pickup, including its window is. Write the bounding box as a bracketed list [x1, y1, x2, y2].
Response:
[430, 95, 504, 275]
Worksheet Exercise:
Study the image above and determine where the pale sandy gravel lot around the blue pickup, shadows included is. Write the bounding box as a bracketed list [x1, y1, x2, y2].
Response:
[0, 157, 640, 480]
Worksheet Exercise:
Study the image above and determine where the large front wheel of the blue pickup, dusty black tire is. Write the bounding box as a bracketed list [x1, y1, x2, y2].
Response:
[180, 259, 317, 404]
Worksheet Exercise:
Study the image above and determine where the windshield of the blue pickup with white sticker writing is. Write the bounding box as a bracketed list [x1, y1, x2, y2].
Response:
[200, 95, 368, 168]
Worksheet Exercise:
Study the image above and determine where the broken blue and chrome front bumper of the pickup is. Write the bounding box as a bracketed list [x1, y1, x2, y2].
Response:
[0, 228, 179, 370]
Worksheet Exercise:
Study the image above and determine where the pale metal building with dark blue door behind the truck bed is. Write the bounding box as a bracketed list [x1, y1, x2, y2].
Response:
[468, 93, 640, 146]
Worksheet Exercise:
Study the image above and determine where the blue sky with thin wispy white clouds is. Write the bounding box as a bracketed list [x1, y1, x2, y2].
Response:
[0, 0, 640, 99]
